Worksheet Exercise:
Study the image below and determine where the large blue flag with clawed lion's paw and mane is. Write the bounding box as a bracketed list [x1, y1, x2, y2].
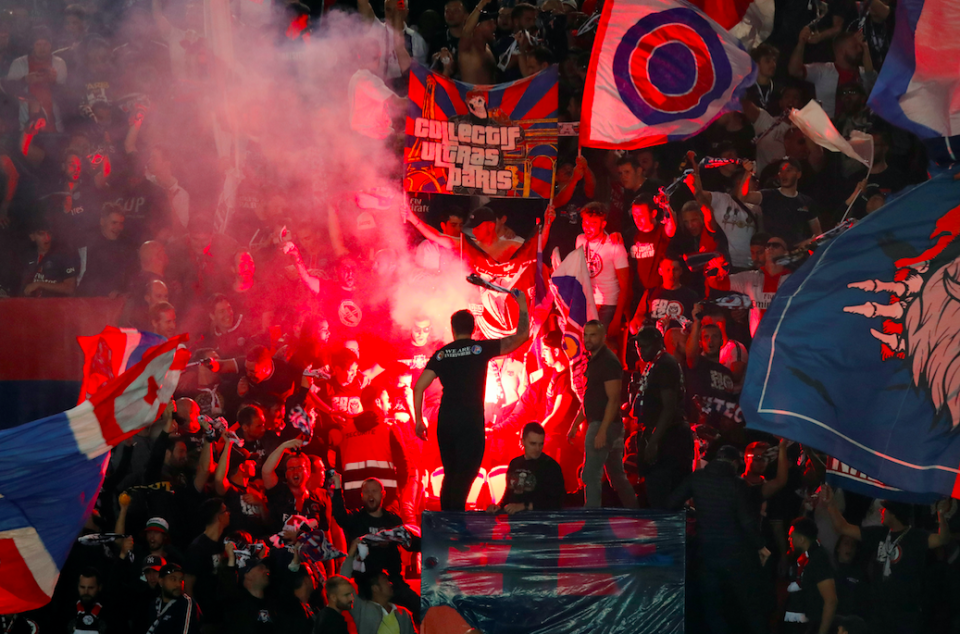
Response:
[740, 174, 960, 501]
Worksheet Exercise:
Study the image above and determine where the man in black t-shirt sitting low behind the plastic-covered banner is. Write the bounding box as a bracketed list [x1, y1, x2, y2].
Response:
[487, 422, 566, 515]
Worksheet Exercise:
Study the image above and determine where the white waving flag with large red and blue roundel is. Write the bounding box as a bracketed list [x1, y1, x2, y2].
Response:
[580, 0, 756, 149]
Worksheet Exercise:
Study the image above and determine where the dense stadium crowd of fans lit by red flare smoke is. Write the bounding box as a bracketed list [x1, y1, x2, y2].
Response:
[0, 0, 960, 634]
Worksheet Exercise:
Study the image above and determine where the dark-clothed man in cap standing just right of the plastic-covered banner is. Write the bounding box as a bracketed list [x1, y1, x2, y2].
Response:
[667, 445, 770, 634]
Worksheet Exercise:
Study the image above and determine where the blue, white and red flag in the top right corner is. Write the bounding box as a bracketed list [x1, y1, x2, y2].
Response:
[869, 0, 960, 139]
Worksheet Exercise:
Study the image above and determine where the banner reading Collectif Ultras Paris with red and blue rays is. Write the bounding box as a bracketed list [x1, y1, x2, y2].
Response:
[403, 63, 559, 198]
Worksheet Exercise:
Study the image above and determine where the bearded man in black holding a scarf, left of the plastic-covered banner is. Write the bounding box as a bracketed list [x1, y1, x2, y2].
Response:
[333, 474, 420, 623]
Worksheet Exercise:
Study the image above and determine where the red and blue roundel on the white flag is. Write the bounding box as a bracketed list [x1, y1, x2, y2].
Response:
[613, 8, 732, 125]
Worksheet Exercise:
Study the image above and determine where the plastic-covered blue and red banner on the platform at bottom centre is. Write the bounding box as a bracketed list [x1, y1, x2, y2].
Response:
[421, 509, 685, 634]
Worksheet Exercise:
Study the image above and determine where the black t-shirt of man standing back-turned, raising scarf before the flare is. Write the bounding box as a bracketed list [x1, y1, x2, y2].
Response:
[426, 339, 500, 419]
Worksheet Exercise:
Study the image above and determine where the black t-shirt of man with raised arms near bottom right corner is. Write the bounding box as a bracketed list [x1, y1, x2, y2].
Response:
[860, 526, 930, 613]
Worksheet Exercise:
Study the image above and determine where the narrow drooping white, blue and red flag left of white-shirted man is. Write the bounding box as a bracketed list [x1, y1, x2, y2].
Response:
[550, 247, 597, 400]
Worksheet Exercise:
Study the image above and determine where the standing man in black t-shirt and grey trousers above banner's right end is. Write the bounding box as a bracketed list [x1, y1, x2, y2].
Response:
[567, 319, 640, 509]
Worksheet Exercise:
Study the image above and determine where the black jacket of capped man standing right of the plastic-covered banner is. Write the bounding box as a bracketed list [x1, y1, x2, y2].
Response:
[667, 460, 764, 561]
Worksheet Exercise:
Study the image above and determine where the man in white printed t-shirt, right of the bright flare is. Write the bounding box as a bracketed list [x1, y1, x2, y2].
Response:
[576, 203, 630, 339]
